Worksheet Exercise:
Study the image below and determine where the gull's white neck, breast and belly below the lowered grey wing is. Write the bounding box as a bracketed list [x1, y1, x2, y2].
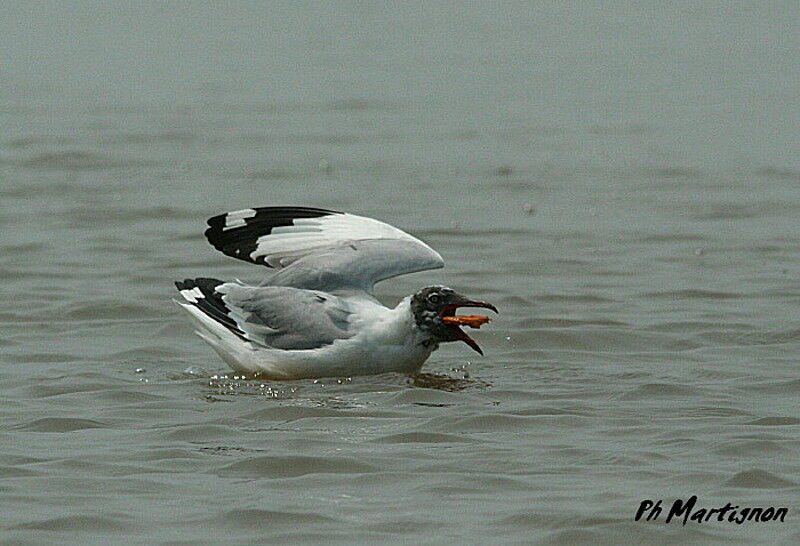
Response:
[179, 298, 438, 379]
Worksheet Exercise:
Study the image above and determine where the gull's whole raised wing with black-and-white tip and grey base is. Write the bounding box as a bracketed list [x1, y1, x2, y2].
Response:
[206, 207, 444, 293]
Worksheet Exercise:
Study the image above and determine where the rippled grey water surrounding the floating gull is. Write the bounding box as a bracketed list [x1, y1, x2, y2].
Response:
[0, 1, 800, 544]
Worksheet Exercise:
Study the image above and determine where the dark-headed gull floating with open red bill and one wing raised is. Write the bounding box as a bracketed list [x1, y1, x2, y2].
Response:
[175, 207, 497, 379]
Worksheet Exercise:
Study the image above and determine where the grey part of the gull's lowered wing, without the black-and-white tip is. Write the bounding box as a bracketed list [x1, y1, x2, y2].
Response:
[216, 283, 353, 350]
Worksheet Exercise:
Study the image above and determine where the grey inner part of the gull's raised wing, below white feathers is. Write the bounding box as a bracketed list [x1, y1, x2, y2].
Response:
[264, 239, 444, 294]
